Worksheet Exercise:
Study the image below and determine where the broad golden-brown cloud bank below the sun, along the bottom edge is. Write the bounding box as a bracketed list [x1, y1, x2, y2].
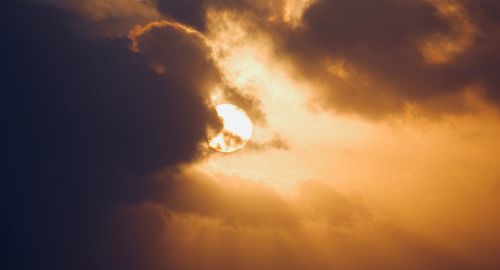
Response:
[92, 170, 478, 269]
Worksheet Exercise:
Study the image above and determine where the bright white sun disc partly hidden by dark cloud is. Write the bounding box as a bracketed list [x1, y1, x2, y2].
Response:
[208, 104, 253, 153]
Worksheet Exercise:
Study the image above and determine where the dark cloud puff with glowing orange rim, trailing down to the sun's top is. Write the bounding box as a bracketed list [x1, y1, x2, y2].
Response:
[129, 21, 266, 124]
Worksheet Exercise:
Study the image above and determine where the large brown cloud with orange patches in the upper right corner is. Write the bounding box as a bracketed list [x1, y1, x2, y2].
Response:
[280, 0, 500, 117]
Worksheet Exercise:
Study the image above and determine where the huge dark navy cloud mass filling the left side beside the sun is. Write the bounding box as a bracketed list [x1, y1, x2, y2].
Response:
[0, 2, 219, 269]
